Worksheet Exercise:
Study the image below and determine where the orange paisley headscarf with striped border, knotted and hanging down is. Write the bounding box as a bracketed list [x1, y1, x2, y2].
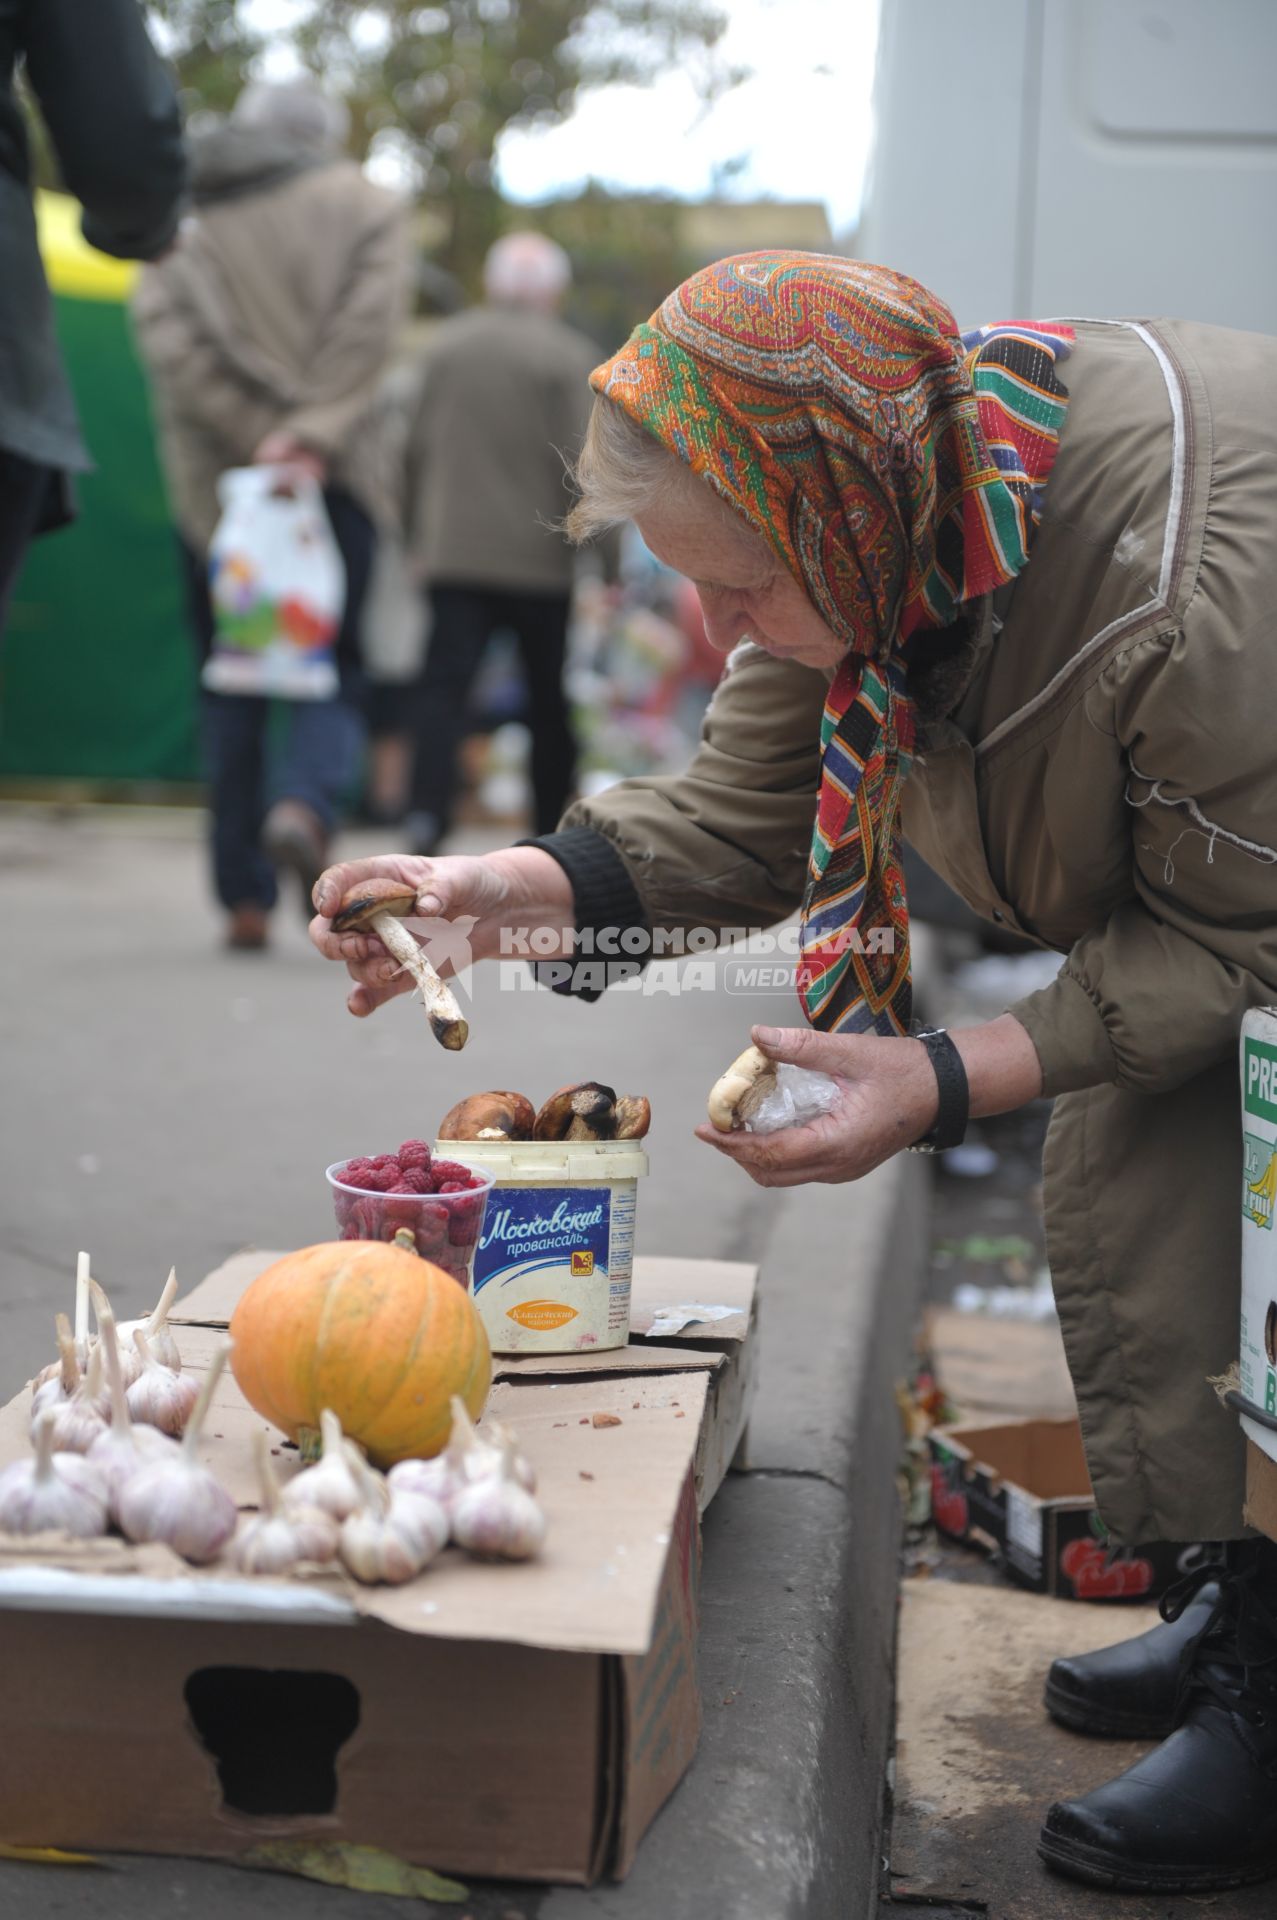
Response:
[591, 252, 1073, 1033]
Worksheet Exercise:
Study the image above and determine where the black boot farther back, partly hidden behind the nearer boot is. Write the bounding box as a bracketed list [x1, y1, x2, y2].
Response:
[1043, 1567, 1219, 1740]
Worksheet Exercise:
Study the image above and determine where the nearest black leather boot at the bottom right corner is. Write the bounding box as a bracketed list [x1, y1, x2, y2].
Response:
[1037, 1540, 1277, 1893]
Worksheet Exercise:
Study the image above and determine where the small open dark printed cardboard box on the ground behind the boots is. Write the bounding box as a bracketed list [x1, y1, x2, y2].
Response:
[928, 1421, 1194, 1599]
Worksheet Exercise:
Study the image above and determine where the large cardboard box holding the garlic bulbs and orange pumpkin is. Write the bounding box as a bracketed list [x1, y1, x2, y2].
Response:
[0, 1254, 753, 1884]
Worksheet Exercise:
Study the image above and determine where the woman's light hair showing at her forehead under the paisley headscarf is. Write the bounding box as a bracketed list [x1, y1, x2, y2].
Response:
[563, 394, 759, 543]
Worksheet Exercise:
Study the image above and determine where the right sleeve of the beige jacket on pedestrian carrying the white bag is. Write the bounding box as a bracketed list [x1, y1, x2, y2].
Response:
[280, 182, 409, 453]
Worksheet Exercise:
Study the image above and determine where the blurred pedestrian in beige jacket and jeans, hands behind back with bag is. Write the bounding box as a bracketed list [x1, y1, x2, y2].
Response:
[133, 81, 407, 948]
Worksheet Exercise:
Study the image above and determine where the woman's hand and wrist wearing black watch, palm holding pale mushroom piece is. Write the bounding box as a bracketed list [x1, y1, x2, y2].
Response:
[697, 1014, 1043, 1187]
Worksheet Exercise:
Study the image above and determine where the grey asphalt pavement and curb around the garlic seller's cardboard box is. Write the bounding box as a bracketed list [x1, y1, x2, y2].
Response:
[0, 806, 926, 1920]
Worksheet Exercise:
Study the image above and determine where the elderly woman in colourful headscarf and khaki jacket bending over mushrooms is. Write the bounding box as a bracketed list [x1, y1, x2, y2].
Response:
[313, 253, 1277, 1891]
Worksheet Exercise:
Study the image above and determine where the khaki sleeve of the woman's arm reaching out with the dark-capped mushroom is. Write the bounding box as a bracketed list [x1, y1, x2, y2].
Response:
[563, 645, 828, 929]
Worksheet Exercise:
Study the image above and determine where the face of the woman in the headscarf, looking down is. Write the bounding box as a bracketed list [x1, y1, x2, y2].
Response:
[638, 495, 847, 668]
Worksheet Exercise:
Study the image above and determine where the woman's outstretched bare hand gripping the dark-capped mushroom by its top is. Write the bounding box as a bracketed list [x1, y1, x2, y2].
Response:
[311, 847, 574, 1020]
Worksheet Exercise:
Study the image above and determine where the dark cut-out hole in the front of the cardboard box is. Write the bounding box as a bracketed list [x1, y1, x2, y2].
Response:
[184, 1667, 359, 1816]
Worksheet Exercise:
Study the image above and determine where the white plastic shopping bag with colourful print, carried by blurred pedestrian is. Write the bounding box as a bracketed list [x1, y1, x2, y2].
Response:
[204, 467, 346, 701]
